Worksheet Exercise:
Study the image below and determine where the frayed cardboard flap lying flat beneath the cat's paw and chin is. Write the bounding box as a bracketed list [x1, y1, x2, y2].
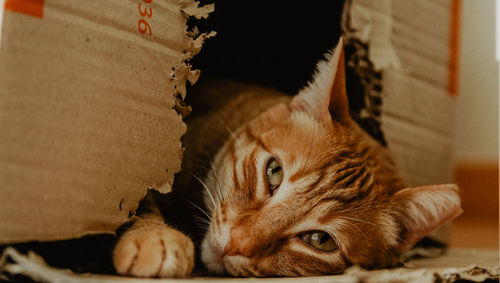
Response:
[0, 248, 500, 283]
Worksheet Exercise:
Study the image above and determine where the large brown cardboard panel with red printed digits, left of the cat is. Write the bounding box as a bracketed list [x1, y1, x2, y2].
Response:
[0, 0, 213, 243]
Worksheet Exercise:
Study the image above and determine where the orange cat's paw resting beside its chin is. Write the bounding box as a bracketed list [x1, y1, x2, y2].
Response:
[113, 227, 194, 277]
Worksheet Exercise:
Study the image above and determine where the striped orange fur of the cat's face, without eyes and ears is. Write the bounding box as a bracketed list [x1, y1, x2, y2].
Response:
[202, 104, 403, 276]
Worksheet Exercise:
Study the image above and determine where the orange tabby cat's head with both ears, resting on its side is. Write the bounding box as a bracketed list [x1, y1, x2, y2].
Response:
[198, 37, 461, 276]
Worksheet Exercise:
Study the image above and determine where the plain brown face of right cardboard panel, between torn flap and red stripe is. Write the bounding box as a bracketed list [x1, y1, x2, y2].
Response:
[383, 0, 455, 186]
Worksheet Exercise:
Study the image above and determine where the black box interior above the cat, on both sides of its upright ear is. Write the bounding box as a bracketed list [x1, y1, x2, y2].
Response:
[187, 0, 386, 145]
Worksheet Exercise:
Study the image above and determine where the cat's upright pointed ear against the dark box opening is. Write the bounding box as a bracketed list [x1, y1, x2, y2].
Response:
[290, 37, 351, 122]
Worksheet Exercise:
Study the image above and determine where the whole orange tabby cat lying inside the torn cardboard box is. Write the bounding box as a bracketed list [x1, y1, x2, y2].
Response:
[113, 38, 462, 277]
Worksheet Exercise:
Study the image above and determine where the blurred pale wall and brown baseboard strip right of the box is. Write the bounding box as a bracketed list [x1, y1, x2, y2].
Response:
[451, 0, 500, 249]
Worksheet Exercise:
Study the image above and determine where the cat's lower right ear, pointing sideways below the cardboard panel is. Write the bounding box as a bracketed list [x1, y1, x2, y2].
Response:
[392, 184, 462, 252]
